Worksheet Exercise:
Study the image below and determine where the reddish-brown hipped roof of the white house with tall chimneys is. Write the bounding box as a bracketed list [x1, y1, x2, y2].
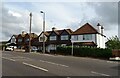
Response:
[72, 23, 98, 35]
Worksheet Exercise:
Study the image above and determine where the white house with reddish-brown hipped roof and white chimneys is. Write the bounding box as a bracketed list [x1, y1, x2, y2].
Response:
[71, 23, 106, 48]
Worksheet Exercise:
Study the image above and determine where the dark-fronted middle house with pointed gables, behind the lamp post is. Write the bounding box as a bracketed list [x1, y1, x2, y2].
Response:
[38, 28, 73, 52]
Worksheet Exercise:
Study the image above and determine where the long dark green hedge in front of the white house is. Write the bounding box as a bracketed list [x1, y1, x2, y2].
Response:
[55, 46, 112, 58]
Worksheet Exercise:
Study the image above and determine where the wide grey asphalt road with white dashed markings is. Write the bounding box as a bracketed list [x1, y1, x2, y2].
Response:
[2, 51, 120, 78]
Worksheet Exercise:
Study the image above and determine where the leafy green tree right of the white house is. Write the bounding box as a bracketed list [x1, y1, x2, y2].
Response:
[106, 36, 120, 49]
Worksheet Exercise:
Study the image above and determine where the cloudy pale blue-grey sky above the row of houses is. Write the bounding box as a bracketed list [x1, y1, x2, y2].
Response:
[0, 1, 118, 41]
